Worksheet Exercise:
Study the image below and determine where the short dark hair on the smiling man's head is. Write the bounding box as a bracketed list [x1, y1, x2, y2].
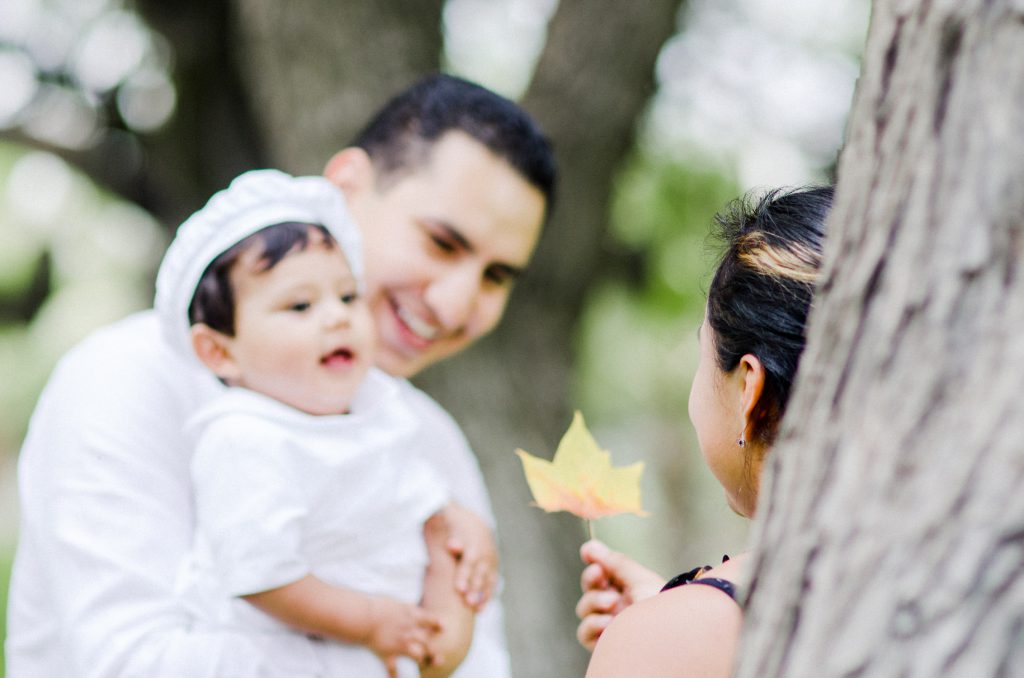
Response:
[349, 74, 557, 212]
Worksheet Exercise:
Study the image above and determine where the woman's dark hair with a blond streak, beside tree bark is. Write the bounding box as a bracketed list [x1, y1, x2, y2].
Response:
[707, 186, 834, 444]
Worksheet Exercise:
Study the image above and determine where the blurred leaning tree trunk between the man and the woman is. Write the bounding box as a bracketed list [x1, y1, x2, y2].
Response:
[421, 0, 681, 678]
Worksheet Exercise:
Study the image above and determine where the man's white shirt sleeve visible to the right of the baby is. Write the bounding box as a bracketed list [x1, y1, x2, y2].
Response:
[402, 381, 511, 678]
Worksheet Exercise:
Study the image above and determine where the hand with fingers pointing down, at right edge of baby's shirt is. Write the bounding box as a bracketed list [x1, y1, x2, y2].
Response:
[428, 504, 498, 611]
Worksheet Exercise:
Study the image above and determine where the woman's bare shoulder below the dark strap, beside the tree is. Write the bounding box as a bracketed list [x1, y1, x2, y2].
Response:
[587, 585, 742, 678]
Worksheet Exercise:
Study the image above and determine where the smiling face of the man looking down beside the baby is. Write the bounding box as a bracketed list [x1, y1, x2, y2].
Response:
[328, 132, 545, 377]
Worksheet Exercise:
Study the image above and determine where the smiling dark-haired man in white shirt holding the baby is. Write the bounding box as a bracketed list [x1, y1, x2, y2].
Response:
[6, 76, 555, 678]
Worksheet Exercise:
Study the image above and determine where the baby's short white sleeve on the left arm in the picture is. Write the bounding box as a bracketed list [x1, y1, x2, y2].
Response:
[191, 415, 310, 596]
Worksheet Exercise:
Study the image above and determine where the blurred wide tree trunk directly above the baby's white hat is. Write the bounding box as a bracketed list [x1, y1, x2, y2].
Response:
[233, 0, 443, 174]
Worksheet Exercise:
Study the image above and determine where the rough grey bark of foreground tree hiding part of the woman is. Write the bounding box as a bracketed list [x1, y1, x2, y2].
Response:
[738, 0, 1024, 678]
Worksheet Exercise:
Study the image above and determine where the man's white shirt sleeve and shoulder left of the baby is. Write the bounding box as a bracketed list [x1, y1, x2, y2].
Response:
[6, 312, 303, 678]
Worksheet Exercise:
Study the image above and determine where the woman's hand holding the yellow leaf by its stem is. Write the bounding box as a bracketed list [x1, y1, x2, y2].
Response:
[575, 540, 666, 651]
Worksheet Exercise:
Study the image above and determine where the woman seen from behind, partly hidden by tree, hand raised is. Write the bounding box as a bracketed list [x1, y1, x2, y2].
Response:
[577, 187, 833, 678]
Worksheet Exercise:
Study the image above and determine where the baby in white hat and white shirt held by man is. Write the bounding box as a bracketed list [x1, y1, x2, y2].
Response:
[156, 170, 473, 678]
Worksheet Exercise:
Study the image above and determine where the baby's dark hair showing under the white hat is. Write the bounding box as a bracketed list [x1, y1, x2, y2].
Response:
[188, 221, 337, 337]
